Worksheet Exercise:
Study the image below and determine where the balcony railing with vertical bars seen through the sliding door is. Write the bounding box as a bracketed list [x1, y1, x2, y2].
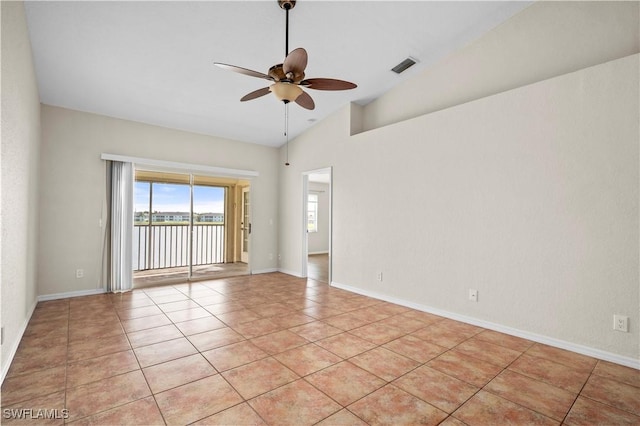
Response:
[133, 224, 225, 271]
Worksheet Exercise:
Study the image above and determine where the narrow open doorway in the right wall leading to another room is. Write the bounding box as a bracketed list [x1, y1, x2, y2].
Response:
[302, 168, 332, 284]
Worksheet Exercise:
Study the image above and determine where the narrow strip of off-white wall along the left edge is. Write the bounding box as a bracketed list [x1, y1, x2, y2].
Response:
[0, 1, 40, 378]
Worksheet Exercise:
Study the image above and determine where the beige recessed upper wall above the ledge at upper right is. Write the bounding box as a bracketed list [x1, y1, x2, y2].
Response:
[362, 1, 640, 133]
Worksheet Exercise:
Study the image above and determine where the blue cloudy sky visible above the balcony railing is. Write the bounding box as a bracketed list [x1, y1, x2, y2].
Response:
[133, 182, 224, 213]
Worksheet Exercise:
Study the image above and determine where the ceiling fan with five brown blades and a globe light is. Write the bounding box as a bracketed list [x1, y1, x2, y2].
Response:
[214, 0, 357, 109]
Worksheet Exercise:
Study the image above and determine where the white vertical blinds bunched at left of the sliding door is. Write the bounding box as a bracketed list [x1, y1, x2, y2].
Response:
[107, 161, 133, 292]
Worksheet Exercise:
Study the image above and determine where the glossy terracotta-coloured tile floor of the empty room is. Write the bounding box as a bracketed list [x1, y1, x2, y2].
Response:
[2, 273, 640, 425]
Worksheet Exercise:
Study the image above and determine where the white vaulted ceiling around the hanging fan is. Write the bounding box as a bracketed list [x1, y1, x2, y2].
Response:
[25, 0, 530, 146]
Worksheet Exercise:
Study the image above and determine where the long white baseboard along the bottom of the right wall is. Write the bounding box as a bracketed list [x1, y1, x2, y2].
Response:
[331, 281, 640, 370]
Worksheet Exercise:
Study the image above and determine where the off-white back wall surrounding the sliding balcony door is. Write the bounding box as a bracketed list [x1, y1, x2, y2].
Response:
[38, 106, 278, 295]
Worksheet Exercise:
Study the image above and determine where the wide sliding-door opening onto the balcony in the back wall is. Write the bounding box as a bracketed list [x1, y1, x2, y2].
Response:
[132, 170, 250, 287]
